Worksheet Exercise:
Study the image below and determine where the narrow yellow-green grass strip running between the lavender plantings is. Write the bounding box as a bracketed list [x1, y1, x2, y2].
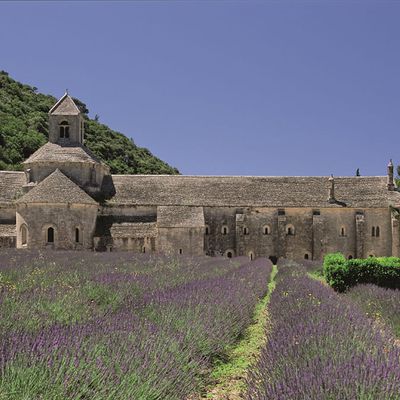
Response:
[204, 265, 278, 400]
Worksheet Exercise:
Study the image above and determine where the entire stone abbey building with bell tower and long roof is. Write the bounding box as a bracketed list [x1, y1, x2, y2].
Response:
[0, 93, 400, 260]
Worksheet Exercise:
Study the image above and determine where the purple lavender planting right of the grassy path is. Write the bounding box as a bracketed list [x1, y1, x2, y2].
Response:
[247, 261, 400, 400]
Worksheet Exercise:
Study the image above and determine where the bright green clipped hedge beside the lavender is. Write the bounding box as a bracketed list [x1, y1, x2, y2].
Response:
[324, 253, 400, 292]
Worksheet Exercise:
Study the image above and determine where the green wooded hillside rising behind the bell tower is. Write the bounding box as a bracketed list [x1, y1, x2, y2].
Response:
[0, 71, 179, 174]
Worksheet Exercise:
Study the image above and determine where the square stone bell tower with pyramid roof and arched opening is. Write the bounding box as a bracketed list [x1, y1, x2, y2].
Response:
[49, 92, 84, 146]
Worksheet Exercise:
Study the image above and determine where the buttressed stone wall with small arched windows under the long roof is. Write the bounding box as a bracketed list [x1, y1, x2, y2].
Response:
[205, 207, 398, 260]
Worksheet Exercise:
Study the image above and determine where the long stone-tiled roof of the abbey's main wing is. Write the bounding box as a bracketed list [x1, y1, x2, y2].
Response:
[109, 175, 400, 208]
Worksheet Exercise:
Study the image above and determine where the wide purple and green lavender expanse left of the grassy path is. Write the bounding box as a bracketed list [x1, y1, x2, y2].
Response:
[0, 252, 272, 400]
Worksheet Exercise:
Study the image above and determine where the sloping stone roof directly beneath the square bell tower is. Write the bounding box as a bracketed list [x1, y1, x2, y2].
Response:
[23, 142, 101, 164]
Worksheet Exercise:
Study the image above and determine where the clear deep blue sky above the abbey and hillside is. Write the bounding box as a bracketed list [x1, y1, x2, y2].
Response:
[0, 0, 400, 176]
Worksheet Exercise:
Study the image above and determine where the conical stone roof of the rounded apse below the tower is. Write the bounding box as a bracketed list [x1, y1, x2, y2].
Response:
[17, 169, 97, 205]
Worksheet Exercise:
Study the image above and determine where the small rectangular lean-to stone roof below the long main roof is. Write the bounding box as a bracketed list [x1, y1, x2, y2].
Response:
[157, 206, 204, 228]
